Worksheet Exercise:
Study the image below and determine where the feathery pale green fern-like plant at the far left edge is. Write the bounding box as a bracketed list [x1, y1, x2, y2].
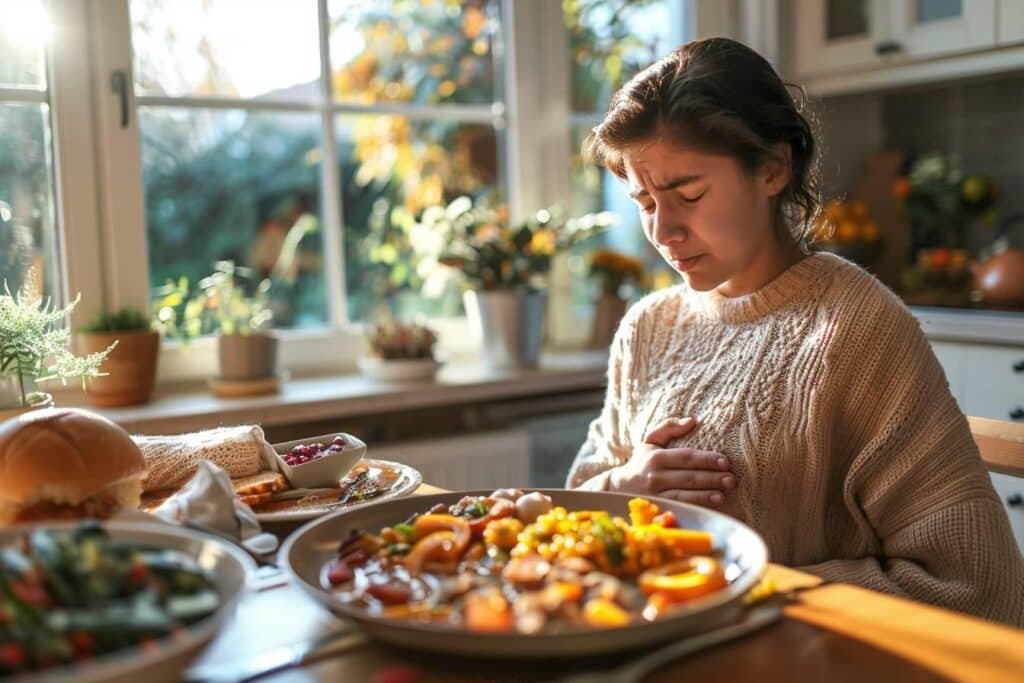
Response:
[0, 276, 117, 419]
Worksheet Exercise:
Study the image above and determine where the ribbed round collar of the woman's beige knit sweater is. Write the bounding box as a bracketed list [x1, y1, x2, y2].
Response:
[691, 252, 839, 323]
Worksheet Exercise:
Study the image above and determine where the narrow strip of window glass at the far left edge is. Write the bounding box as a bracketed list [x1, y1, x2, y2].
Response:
[0, 0, 61, 300]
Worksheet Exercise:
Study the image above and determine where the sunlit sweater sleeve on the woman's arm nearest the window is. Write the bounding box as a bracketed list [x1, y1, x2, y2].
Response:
[565, 304, 640, 490]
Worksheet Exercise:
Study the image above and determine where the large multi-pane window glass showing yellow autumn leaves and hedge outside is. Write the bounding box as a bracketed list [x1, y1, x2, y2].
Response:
[131, 0, 500, 328]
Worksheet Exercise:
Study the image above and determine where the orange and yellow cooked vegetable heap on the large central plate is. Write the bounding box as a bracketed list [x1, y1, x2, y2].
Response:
[322, 489, 728, 634]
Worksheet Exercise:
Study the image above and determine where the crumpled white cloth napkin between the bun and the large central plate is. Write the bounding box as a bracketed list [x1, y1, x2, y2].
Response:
[153, 460, 278, 555]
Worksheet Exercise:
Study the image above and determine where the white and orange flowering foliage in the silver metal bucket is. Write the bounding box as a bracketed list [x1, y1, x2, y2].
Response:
[410, 197, 615, 296]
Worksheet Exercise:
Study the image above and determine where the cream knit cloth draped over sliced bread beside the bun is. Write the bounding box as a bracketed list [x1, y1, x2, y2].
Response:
[132, 425, 279, 490]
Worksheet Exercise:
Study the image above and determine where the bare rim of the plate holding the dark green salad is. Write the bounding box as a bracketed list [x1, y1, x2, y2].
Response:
[0, 521, 250, 683]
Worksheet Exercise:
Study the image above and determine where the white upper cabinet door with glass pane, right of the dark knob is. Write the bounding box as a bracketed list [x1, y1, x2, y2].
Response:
[888, 0, 996, 58]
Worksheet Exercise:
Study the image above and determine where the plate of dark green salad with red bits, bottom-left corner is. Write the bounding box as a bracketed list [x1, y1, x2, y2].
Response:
[0, 521, 255, 683]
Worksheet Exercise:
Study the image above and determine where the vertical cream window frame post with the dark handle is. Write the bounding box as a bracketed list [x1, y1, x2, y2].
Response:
[89, 0, 150, 310]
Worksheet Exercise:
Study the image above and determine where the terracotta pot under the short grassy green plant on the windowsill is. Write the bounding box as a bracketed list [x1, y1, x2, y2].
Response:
[75, 330, 160, 408]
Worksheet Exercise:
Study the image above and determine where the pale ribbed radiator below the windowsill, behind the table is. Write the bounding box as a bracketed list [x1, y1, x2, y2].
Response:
[367, 429, 529, 490]
